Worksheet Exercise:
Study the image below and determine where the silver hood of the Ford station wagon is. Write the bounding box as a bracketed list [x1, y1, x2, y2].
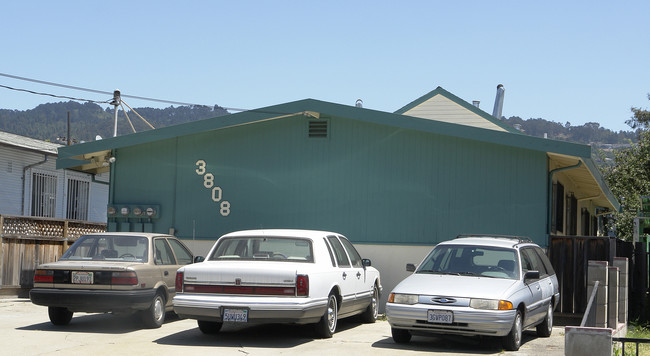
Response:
[393, 273, 520, 299]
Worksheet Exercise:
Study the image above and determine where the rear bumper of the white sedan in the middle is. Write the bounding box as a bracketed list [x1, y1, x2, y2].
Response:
[173, 294, 327, 324]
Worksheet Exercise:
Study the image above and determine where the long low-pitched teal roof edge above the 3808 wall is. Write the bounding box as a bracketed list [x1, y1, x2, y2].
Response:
[57, 94, 619, 209]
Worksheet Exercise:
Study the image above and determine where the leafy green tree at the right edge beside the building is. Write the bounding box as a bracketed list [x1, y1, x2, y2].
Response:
[604, 95, 650, 241]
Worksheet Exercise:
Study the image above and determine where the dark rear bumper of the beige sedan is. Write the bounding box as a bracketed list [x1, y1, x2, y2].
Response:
[29, 288, 156, 313]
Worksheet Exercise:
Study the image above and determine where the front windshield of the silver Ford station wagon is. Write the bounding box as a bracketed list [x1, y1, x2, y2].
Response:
[416, 245, 519, 279]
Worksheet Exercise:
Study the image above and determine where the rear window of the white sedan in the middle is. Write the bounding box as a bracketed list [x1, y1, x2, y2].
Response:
[208, 236, 314, 262]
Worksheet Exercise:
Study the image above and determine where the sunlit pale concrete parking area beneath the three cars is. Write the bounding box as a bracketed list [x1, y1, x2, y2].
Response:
[0, 298, 564, 356]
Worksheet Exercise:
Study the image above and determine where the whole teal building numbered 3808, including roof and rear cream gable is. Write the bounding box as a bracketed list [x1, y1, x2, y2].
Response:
[57, 87, 619, 298]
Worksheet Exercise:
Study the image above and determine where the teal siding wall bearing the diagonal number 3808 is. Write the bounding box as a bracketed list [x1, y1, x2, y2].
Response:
[112, 116, 547, 245]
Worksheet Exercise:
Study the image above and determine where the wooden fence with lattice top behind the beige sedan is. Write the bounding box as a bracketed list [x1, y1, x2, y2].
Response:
[0, 215, 106, 290]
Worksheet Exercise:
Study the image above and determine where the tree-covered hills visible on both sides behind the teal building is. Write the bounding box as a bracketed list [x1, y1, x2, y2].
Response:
[0, 101, 637, 151]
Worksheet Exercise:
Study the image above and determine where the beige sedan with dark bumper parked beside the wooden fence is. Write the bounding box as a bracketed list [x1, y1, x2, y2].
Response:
[29, 232, 201, 328]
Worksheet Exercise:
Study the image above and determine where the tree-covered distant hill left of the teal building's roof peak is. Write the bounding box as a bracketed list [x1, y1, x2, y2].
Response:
[0, 101, 229, 143]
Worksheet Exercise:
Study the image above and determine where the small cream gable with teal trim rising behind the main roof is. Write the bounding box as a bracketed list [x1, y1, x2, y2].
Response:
[395, 87, 521, 134]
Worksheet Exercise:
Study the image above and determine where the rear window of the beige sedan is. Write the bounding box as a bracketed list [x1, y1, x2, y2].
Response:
[61, 235, 149, 262]
